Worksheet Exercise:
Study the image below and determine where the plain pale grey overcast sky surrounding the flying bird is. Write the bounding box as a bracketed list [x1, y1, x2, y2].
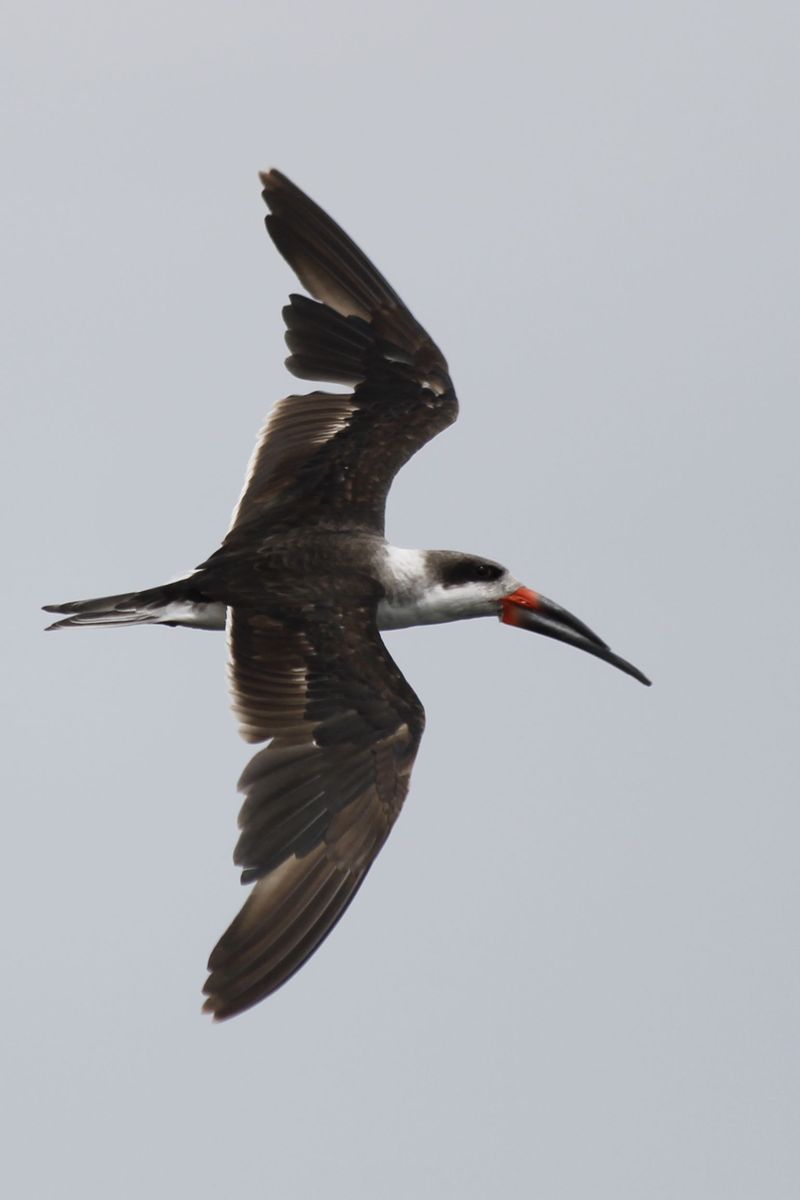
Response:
[0, 0, 800, 1200]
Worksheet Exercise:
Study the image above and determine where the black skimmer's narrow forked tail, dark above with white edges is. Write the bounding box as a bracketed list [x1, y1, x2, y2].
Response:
[44, 578, 225, 629]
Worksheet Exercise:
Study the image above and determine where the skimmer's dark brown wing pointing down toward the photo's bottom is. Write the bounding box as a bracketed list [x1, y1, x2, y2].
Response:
[204, 602, 425, 1020]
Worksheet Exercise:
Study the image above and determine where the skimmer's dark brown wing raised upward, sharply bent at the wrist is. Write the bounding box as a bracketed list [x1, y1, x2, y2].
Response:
[227, 170, 458, 545]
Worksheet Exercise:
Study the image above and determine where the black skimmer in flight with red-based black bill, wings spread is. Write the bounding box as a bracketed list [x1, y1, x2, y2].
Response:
[47, 170, 649, 1020]
